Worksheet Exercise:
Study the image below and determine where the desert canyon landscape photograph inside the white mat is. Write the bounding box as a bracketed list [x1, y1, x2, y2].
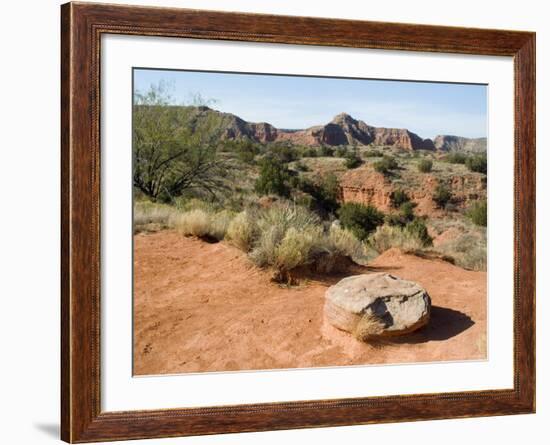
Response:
[134, 67, 488, 376]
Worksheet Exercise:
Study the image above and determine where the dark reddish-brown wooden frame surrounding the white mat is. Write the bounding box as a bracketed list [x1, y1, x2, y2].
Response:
[61, 3, 535, 443]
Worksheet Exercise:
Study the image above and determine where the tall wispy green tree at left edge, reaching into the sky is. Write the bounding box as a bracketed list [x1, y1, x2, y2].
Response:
[132, 83, 230, 201]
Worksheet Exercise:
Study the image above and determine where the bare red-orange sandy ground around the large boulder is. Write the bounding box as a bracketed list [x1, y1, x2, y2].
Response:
[134, 231, 486, 375]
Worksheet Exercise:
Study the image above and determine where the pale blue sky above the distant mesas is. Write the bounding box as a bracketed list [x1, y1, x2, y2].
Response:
[134, 69, 487, 138]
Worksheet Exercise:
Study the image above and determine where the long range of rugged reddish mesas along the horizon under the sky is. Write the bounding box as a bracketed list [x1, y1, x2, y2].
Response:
[141, 106, 487, 152]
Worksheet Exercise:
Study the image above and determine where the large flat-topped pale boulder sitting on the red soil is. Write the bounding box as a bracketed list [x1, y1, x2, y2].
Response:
[325, 273, 431, 340]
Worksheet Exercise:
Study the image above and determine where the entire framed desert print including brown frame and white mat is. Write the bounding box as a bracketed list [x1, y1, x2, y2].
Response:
[61, 3, 535, 443]
